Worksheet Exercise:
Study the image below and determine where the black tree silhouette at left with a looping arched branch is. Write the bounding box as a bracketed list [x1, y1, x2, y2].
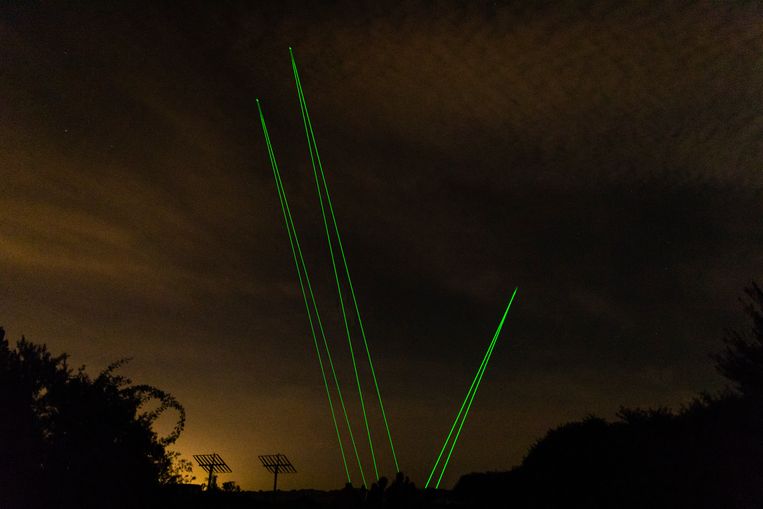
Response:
[0, 328, 185, 508]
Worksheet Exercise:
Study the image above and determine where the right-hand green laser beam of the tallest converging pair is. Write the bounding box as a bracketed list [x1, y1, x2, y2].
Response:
[289, 48, 400, 477]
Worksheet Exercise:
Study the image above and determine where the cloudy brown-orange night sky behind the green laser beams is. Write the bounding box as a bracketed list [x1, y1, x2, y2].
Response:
[0, 0, 763, 489]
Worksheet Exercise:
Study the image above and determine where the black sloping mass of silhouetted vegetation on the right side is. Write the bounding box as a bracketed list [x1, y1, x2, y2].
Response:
[454, 284, 763, 508]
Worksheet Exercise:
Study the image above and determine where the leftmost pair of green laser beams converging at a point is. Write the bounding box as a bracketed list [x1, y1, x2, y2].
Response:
[257, 100, 366, 484]
